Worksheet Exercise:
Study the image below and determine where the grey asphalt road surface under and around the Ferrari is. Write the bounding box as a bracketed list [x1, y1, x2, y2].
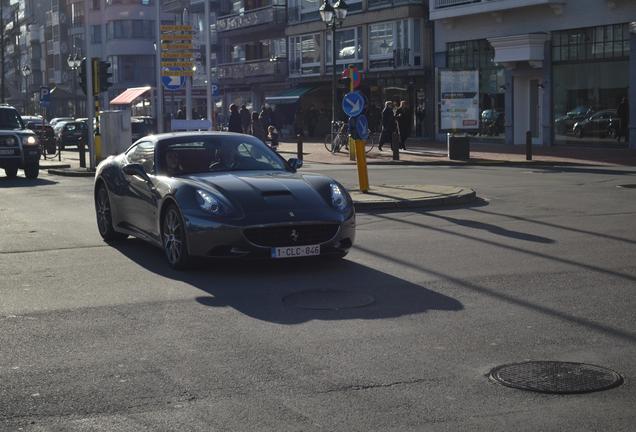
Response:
[0, 166, 636, 431]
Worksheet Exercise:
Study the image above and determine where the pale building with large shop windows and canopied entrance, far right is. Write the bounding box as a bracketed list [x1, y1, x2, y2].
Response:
[429, 0, 636, 147]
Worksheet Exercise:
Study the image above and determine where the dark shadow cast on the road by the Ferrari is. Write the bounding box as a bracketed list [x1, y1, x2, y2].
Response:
[116, 239, 463, 324]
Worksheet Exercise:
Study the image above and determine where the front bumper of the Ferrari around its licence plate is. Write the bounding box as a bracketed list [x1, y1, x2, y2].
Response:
[184, 212, 356, 258]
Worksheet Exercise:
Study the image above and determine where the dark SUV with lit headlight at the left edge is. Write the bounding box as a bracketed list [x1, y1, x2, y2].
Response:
[0, 105, 40, 178]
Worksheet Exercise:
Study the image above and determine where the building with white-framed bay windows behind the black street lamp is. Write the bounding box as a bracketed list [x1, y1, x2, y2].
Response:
[284, 0, 434, 136]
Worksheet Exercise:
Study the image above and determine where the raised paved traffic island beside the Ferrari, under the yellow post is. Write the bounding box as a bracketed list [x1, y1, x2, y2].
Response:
[349, 185, 477, 211]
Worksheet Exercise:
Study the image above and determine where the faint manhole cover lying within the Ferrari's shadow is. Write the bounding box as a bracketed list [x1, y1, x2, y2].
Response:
[283, 290, 375, 310]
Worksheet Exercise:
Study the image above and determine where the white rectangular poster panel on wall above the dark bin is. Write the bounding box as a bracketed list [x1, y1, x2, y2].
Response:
[440, 70, 479, 130]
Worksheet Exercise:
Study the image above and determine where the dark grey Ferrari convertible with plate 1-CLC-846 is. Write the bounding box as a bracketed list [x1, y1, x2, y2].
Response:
[95, 132, 355, 268]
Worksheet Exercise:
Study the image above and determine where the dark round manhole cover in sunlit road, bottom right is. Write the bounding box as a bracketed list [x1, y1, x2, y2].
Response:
[490, 361, 623, 394]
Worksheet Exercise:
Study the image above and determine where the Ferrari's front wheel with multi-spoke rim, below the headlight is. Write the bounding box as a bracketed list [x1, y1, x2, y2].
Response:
[161, 204, 191, 270]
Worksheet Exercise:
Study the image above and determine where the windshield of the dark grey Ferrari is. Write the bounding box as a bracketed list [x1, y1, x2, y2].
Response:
[158, 135, 286, 176]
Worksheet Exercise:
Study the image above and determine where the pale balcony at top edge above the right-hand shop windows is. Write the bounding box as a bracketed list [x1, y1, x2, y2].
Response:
[429, 0, 567, 20]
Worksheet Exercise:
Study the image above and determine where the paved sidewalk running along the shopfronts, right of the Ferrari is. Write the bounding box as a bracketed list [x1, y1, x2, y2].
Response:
[279, 138, 636, 166]
